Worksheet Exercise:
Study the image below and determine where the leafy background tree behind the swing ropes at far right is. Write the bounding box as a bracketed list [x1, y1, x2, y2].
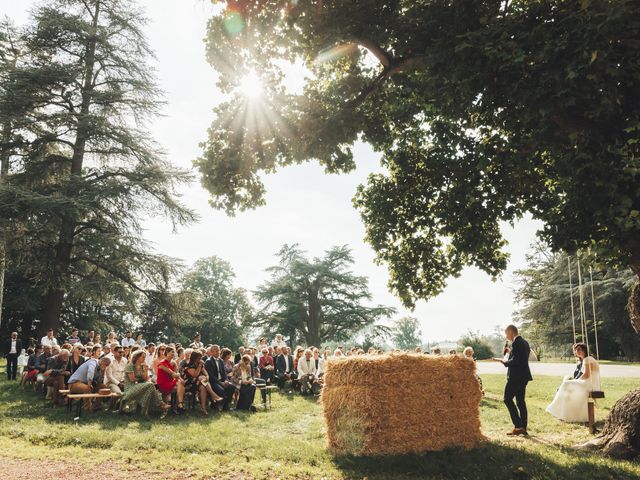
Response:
[515, 244, 640, 360]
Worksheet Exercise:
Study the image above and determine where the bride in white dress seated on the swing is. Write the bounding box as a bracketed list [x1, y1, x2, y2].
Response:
[547, 343, 600, 423]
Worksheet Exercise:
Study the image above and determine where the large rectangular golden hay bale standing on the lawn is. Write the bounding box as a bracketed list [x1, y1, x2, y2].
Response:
[322, 354, 484, 455]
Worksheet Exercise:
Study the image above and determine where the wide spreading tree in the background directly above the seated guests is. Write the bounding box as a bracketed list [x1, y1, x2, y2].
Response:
[255, 245, 393, 347]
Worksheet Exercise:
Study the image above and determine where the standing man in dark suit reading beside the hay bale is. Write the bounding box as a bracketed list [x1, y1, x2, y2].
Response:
[494, 325, 533, 435]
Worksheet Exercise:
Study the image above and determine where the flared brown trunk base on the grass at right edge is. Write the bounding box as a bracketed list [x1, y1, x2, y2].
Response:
[577, 389, 640, 460]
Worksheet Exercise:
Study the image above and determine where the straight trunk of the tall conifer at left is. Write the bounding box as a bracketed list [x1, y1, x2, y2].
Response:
[39, 1, 101, 334]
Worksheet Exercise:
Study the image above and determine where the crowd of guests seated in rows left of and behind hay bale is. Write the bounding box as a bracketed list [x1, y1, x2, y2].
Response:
[7, 329, 482, 415]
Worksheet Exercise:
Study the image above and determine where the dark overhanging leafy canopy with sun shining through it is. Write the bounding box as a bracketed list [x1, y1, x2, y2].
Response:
[195, 0, 640, 329]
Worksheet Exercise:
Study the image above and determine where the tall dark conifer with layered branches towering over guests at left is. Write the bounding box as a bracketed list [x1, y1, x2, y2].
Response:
[0, 0, 193, 330]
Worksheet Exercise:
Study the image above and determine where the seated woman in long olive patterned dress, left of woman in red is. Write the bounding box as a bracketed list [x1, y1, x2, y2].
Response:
[122, 350, 169, 416]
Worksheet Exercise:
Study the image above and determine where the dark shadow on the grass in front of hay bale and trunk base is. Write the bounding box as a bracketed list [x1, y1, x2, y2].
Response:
[333, 439, 638, 480]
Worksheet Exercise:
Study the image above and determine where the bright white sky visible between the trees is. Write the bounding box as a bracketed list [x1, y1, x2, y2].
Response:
[0, 0, 540, 342]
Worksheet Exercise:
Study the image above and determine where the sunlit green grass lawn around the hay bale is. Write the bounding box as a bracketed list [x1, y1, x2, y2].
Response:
[0, 365, 640, 480]
